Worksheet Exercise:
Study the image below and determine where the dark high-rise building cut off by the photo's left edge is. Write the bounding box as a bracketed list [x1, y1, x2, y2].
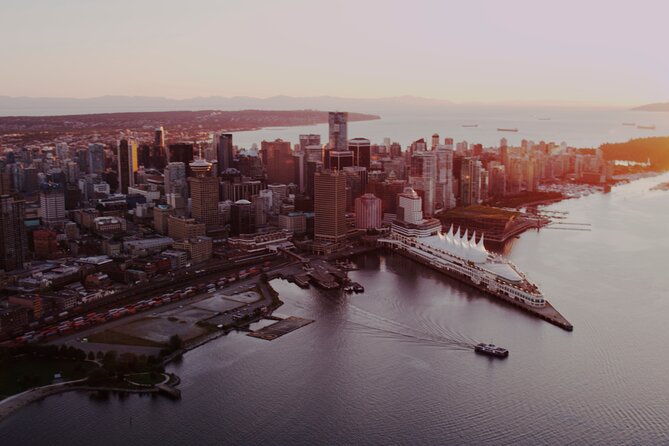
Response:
[0, 195, 28, 271]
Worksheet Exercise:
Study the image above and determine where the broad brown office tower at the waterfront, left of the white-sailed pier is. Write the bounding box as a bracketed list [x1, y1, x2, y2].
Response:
[314, 171, 347, 243]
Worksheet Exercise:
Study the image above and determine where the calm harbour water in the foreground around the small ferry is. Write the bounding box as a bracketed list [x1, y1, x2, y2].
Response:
[0, 174, 669, 445]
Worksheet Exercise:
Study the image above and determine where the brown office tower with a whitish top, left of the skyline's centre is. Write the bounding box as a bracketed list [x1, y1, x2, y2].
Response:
[189, 159, 220, 229]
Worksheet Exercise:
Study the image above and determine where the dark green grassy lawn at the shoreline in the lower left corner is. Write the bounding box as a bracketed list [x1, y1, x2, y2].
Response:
[0, 358, 97, 399]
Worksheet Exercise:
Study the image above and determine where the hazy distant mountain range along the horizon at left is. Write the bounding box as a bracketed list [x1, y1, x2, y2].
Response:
[0, 96, 455, 116]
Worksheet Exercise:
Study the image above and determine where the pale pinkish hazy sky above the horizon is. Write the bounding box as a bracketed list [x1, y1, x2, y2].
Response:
[0, 0, 669, 105]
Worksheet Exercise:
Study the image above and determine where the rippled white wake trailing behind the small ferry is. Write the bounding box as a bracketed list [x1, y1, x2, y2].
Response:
[348, 305, 476, 350]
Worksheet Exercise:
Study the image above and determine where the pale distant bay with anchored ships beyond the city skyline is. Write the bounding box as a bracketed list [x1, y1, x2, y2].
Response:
[234, 107, 669, 148]
